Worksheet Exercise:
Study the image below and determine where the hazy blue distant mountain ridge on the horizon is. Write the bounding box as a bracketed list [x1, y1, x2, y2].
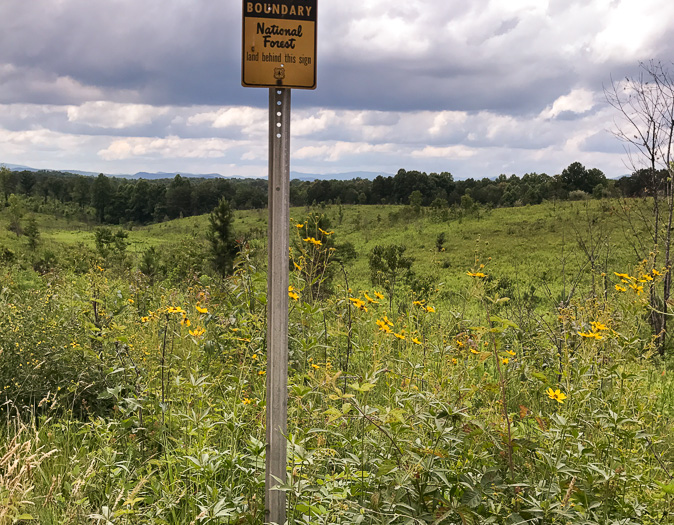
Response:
[0, 163, 393, 181]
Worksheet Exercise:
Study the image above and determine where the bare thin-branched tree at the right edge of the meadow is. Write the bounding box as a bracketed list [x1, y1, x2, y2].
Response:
[604, 60, 674, 355]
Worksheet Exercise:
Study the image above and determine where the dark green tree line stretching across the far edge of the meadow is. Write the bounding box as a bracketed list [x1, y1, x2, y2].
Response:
[0, 162, 666, 224]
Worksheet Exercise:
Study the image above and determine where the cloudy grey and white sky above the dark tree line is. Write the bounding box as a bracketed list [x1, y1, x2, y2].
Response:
[0, 0, 674, 178]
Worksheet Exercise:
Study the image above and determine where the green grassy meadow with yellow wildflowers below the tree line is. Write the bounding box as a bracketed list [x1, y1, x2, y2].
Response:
[0, 200, 674, 525]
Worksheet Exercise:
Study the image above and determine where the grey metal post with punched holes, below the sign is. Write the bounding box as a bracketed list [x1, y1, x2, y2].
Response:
[265, 88, 290, 525]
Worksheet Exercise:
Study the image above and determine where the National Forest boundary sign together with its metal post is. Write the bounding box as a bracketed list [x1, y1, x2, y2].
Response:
[241, 0, 317, 525]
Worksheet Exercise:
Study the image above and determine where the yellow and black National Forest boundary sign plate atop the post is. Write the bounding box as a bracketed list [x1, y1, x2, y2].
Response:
[241, 0, 317, 89]
